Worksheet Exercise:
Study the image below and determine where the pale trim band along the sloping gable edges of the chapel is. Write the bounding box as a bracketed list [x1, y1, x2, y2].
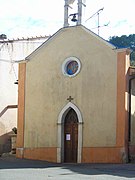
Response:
[23, 25, 117, 61]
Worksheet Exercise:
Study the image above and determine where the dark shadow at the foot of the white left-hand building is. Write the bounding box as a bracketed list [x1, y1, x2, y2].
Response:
[0, 131, 12, 155]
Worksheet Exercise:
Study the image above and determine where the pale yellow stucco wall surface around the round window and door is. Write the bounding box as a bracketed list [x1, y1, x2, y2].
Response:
[24, 26, 117, 147]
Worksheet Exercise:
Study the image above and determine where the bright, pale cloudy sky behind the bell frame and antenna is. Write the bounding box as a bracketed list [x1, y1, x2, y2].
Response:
[0, 0, 135, 39]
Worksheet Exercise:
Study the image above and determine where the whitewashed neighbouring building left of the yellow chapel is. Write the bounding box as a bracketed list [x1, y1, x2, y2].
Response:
[0, 36, 48, 154]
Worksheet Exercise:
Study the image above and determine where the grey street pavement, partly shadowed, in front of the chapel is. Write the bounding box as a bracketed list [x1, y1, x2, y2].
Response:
[0, 156, 135, 180]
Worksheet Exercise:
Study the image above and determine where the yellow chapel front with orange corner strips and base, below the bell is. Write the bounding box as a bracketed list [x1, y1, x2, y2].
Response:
[17, 25, 135, 163]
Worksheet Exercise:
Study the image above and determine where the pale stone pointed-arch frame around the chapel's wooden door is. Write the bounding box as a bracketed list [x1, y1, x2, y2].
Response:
[57, 102, 83, 163]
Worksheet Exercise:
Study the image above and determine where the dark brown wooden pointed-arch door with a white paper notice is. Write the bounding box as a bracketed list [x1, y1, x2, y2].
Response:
[64, 109, 78, 163]
